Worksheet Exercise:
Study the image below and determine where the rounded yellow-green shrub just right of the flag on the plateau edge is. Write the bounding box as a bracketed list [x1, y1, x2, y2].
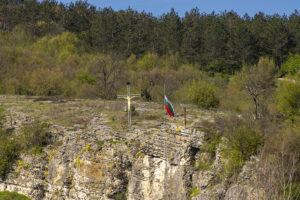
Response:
[188, 81, 219, 108]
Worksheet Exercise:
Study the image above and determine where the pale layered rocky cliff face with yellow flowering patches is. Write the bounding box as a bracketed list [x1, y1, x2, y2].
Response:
[0, 96, 259, 200]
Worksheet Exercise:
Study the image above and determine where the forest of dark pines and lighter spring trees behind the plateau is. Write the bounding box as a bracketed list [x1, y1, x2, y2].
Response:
[0, 0, 300, 101]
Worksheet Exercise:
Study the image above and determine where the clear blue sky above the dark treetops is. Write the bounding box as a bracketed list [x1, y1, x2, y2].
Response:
[60, 0, 300, 16]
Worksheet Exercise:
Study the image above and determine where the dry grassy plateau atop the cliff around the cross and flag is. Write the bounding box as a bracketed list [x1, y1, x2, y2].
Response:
[0, 96, 230, 132]
